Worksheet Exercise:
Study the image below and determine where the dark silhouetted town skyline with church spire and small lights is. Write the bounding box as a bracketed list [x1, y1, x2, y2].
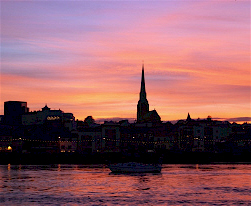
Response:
[0, 65, 251, 163]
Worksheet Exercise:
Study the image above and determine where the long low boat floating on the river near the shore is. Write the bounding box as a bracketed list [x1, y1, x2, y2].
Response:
[108, 162, 162, 173]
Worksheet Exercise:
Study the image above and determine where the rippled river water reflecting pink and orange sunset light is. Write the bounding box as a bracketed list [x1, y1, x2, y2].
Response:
[0, 164, 251, 205]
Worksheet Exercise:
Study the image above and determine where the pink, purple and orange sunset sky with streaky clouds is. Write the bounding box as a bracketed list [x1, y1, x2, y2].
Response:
[0, 0, 251, 122]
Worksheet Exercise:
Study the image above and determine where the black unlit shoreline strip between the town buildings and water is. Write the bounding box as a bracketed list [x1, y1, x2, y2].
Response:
[0, 152, 251, 165]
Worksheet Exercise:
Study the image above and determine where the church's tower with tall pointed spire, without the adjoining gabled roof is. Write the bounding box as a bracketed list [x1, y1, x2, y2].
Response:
[137, 64, 149, 122]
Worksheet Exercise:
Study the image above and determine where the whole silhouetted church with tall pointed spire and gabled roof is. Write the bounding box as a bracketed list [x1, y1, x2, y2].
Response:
[137, 64, 161, 123]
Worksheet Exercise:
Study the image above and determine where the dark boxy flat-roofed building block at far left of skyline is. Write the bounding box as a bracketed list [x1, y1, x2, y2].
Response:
[4, 101, 29, 126]
